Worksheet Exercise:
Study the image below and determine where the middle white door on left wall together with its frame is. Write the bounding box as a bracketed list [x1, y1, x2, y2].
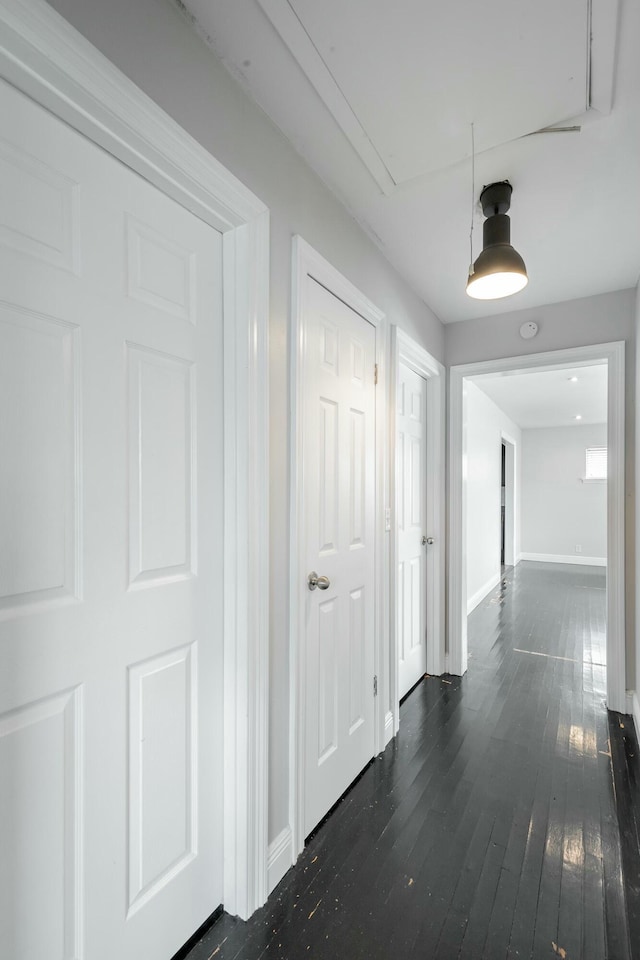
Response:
[290, 237, 389, 863]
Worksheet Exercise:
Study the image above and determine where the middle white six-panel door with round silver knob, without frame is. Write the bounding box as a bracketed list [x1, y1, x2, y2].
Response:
[301, 278, 376, 835]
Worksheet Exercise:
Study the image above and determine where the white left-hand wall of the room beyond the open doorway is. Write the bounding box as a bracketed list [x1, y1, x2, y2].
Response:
[465, 381, 521, 612]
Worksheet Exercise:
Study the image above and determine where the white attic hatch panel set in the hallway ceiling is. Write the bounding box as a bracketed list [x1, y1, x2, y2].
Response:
[258, 0, 589, 192]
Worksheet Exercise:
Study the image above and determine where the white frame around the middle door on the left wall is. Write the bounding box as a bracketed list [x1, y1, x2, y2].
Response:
[289, 236, 389, 863]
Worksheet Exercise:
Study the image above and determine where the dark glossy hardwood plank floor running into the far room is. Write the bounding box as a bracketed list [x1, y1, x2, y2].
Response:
[184, 562, 630, 960]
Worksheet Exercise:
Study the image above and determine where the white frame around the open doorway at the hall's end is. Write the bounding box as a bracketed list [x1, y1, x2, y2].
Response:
[449, 341, 627, 713]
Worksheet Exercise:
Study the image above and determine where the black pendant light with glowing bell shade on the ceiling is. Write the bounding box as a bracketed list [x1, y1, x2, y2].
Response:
[467, 180, 529, 300]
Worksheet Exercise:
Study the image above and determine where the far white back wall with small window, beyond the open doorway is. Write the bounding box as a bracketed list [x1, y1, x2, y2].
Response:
[520, 423, 607, 563]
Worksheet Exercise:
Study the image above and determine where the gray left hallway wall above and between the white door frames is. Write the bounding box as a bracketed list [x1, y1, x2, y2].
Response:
[45, 0, 444, 840]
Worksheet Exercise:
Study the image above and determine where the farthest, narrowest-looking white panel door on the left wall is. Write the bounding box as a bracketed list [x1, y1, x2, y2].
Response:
[396, 363, 428, 697]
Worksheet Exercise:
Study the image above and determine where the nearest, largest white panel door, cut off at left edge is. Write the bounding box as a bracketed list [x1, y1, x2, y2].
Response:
[0, 79, 222, 960]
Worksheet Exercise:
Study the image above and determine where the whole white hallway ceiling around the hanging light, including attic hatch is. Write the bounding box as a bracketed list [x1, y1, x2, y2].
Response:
[180, 0, 640, 323]
